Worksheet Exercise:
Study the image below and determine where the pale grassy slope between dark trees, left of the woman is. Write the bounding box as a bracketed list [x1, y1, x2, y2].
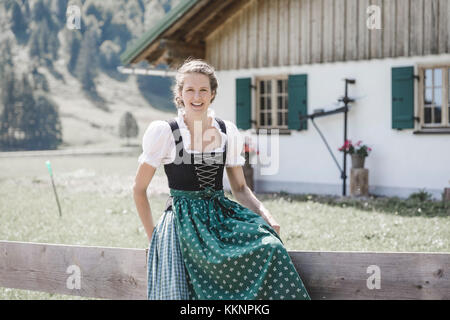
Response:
[42, 48, 174, 149]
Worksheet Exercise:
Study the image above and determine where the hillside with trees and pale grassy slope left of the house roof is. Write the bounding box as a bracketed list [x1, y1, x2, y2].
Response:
[0, 0, 179, 149]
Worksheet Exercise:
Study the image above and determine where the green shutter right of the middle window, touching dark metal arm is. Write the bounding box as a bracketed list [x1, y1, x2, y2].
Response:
[288, 74, 308, 130]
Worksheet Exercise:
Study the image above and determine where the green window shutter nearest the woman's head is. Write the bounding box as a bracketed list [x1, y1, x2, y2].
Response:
[236, 78, 252, 130]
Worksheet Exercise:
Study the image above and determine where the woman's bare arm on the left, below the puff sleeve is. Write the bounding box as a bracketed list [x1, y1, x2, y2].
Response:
[133, 162, 156, 242]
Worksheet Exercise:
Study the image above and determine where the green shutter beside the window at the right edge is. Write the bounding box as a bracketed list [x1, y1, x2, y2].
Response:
[392, 67, 414, 129]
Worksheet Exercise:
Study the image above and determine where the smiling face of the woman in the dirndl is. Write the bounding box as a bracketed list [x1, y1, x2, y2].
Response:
[181, 73, 214, 115]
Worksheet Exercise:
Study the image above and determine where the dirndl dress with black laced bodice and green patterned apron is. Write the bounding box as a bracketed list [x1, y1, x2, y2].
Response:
[147, 118, 310, 300]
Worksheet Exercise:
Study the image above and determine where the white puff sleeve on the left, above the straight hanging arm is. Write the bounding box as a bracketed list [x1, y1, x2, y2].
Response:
[138, 120, 173, 168]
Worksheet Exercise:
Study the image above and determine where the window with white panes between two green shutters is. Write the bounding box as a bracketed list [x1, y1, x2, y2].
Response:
[256, 76, 288, 129]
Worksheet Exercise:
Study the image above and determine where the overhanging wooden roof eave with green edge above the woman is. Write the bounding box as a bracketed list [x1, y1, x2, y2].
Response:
[120, 0, 250, 65]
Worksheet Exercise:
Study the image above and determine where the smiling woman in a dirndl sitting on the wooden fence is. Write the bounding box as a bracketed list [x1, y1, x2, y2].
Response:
[134, 60, 309, 299]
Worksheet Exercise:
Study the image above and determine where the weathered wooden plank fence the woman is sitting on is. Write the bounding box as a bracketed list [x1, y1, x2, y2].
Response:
[0, 241, 450, 300]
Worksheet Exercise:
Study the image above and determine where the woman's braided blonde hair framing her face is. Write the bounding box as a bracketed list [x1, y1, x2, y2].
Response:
[172, 58, 218, 108]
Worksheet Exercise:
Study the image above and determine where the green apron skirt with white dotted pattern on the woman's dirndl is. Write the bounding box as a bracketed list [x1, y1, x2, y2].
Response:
[170, 189, 310, 300]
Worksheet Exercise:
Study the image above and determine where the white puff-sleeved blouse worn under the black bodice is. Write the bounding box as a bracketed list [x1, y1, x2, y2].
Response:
[138, 108, 245, 168]
